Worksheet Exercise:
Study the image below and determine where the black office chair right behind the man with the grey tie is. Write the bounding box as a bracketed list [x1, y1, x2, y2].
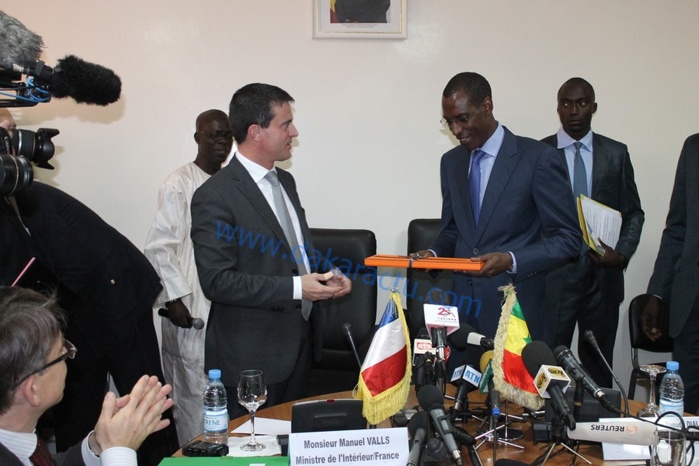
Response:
[309, 228, 377, 396]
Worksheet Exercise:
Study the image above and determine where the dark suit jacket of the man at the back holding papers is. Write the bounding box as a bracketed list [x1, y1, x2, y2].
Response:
[542, 133, 645, 306]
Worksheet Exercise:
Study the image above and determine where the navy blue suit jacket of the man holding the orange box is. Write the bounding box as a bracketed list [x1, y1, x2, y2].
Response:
[431, 125, 581, 340]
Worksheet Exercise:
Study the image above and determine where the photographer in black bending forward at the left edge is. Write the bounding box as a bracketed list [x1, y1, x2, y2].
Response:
[0, 109, 179, 466]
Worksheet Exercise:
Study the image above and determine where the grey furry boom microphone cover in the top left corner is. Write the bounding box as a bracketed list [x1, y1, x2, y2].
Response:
[0, 11, 43, 68]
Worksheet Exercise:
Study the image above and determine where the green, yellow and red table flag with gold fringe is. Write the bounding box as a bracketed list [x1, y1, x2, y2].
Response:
[493, 285, 544, 410]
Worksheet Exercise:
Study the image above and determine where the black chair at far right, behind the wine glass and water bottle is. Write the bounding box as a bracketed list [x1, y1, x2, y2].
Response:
[629, 294, 672, 400]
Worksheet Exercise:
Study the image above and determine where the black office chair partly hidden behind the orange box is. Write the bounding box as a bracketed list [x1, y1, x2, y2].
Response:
[405, 218, 454, 341]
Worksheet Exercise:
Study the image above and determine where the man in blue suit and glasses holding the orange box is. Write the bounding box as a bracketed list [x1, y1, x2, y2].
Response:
[418, 72, 581, 365]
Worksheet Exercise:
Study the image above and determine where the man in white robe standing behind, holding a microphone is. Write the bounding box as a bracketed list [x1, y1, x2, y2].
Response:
[145, 110, 234, 445]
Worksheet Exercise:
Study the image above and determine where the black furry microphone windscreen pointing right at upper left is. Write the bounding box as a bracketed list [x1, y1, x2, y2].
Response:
[51, 55, 121, 106]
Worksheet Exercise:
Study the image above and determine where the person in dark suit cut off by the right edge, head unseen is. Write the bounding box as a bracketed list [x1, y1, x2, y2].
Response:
[642, 134, 699, 413]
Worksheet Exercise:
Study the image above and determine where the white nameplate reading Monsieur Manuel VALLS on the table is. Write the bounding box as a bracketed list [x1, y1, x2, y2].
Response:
[289, 427, 408, 466]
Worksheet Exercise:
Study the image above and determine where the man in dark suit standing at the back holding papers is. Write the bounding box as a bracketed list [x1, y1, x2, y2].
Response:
[543, 78, 645, 387]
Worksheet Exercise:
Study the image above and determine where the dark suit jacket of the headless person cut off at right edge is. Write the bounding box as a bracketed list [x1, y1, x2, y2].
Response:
[648, 134, 699, 338]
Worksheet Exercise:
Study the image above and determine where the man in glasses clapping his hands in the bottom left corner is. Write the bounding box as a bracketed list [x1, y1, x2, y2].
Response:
[0, 286, 172, 466]
